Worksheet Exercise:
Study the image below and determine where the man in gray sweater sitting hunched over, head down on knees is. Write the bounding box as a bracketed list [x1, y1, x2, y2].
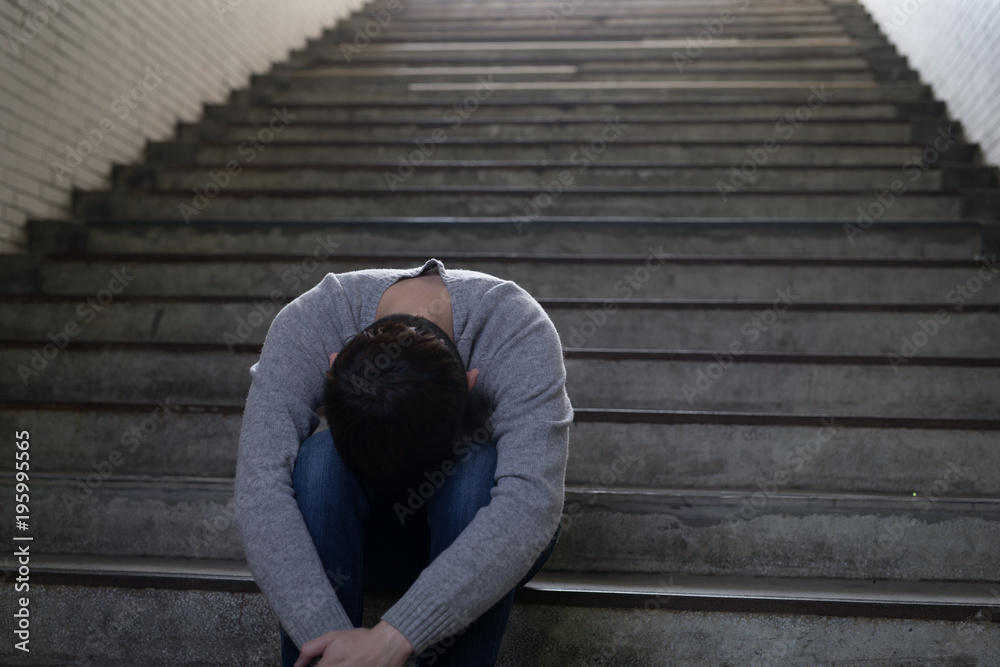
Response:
[229, 259, 573, 667]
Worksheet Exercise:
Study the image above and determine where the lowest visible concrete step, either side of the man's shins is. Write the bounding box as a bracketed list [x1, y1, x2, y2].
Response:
[0, 554, 1000, 667]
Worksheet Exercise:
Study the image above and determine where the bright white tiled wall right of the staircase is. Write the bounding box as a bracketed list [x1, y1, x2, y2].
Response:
[861, 0, 1000, 165]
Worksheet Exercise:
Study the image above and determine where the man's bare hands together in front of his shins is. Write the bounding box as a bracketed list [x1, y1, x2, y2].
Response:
[295, 621, 413, 667]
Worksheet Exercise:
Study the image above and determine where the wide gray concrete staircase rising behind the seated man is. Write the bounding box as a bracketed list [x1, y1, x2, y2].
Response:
[0, 0, 1000, 667]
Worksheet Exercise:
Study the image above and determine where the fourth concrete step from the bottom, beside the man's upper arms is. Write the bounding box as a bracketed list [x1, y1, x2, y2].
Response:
[0, 340, 1000, 419]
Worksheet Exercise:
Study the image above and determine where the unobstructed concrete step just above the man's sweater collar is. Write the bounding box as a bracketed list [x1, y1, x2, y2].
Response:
[25, 220, 983, 260]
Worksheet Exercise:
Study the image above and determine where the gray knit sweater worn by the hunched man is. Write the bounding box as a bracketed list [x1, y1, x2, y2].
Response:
[235, 259, 573, 653]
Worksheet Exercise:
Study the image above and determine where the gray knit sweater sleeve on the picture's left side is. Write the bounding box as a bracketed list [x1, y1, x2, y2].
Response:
[235, 292, 353, 647]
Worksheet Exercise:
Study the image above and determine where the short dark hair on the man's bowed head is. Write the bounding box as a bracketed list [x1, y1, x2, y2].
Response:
[323, 314, 470, 494]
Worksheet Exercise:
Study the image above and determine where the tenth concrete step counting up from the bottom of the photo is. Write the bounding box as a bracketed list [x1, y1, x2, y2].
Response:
[146, 139, 975, 166]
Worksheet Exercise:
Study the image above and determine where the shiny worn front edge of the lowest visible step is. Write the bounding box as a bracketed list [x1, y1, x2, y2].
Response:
[0, 554, 1000, 621]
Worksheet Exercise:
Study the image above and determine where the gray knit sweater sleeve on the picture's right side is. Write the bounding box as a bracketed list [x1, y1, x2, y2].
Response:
[382, 282, 573, 654]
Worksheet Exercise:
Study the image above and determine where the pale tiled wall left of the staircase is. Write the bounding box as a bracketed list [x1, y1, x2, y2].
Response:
[0, 0, 362, 252]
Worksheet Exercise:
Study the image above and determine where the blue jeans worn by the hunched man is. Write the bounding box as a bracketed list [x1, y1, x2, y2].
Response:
[279, 431, 561, 667]
